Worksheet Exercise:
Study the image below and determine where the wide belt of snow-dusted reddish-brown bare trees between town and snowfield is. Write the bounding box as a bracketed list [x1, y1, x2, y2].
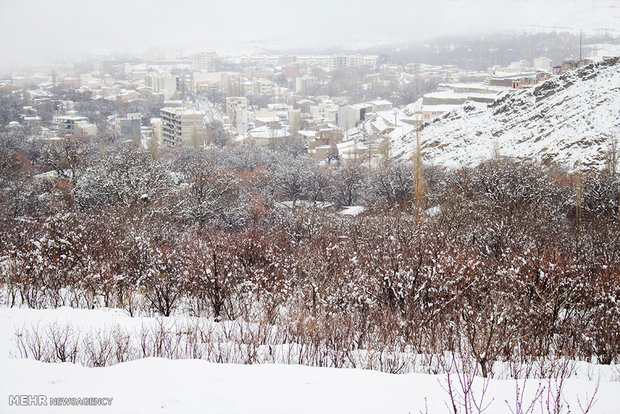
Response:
[0, 133, 620, 376]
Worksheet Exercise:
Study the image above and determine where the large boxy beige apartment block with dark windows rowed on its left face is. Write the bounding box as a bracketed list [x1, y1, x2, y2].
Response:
[161, 107, 204, 147]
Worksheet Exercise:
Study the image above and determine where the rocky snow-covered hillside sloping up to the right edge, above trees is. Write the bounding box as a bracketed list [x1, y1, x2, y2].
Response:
[392, 58, 620, 168]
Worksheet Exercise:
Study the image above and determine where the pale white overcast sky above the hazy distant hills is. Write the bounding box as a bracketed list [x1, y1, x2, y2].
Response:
[0, 0, 620, 65]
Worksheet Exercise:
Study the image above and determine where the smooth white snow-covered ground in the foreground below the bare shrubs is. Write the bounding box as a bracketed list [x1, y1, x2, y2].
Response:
[0, 308, 620, 414]
